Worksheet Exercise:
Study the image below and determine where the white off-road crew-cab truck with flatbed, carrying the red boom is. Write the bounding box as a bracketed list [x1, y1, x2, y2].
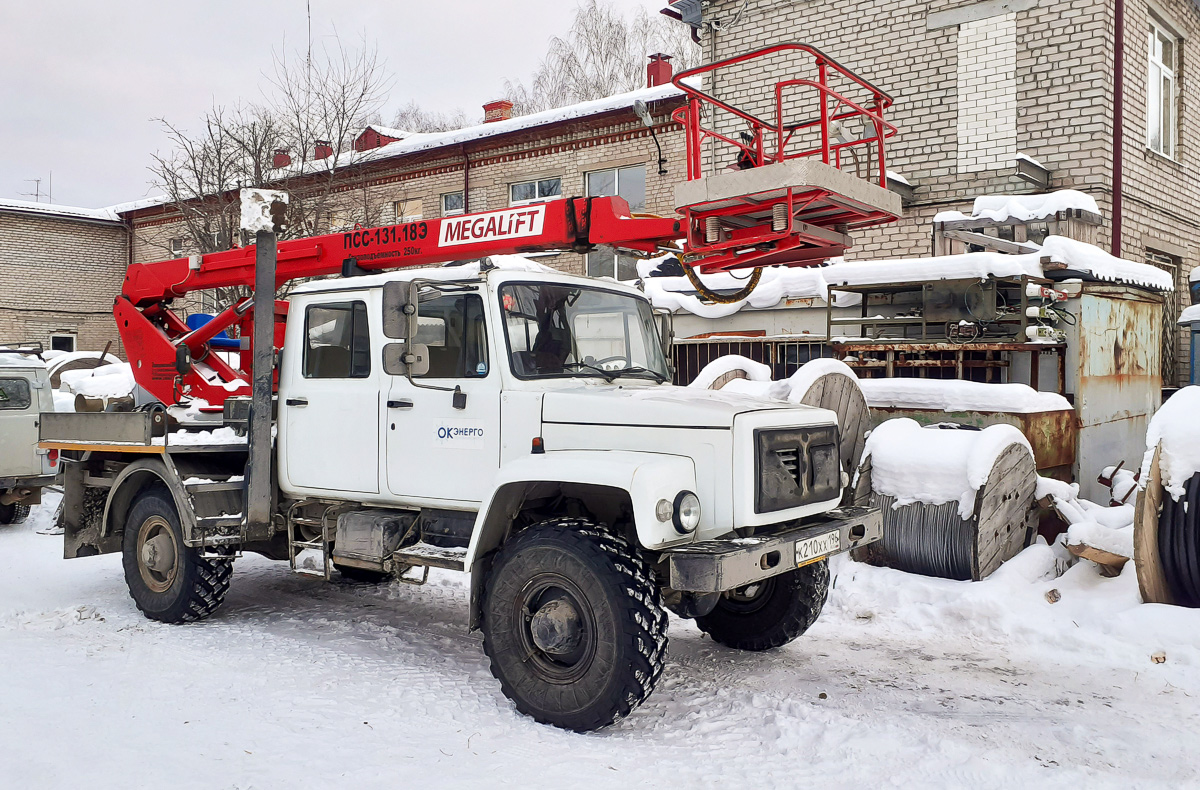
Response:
[42, 264, 881, 730]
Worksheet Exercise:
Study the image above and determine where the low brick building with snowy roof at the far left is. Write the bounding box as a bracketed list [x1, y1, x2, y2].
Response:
[0, 199, 128, 352]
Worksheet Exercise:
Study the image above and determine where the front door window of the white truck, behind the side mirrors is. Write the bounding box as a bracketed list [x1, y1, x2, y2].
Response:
[415, 294, 487, 378]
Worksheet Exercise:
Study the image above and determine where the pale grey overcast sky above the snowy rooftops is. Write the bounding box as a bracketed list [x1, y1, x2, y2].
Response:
[0, 0, 666, 207]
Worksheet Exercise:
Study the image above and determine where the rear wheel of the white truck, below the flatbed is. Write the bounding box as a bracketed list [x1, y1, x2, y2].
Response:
[121, 487, 233, 623]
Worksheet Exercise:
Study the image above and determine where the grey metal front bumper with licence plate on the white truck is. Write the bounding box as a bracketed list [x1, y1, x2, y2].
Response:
[662, 507, 883, 593]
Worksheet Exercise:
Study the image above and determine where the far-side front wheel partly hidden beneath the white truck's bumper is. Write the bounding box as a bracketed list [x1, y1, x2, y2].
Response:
[696, 559, 829, 651]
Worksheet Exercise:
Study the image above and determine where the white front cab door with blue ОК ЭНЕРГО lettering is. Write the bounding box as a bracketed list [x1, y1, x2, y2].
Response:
[384, 292, 500, 504]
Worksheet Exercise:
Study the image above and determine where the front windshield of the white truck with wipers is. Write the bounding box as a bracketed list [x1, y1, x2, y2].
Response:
[500, 282, 670, 382]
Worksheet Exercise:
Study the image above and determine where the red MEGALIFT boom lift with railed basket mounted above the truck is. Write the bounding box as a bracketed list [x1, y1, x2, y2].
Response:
[113, 43, 896, 409]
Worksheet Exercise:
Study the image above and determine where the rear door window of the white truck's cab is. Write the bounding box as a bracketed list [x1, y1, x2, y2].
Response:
[304, 301, 371, 378]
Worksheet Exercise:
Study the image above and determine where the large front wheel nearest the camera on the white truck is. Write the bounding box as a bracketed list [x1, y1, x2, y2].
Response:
[482, 519, 667, 732]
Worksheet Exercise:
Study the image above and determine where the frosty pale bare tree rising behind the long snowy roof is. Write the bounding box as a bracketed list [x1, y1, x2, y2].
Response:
[504, 0, 700, 115]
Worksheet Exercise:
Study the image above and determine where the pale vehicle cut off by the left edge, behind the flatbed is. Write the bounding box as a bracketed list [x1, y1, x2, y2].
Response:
[0, 343, 59, 525]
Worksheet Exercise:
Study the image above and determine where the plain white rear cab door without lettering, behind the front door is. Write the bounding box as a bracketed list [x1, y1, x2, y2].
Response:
[280, 294, 383, 493]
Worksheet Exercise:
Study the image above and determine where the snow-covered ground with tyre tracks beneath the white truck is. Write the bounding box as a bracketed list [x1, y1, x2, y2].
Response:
[0, 494, 1200, 790]
